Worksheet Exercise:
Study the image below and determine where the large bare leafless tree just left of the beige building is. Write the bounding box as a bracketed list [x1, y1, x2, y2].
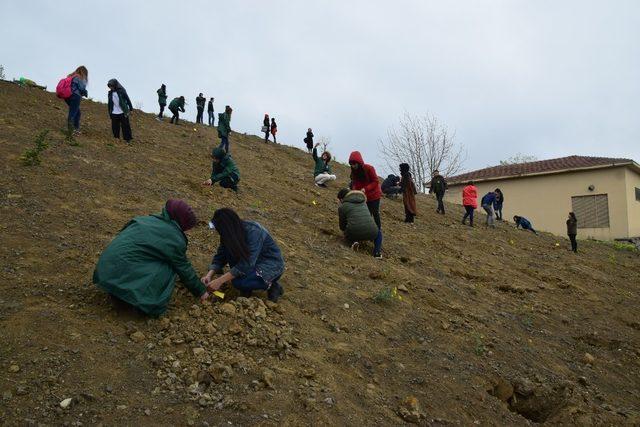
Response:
[379, 112, 466, 192]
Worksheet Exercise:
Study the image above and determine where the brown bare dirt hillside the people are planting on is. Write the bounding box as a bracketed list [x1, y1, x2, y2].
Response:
[0, 83, 640, 426]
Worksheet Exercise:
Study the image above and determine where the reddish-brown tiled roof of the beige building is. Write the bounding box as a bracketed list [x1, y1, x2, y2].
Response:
[447, 156, 634, 184]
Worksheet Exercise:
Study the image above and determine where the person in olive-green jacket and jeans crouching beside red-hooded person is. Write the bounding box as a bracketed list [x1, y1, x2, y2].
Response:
[338, 188, 382, 255]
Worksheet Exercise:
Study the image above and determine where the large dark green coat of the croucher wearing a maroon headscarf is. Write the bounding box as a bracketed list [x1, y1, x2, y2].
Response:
[93, 210, 206, 316]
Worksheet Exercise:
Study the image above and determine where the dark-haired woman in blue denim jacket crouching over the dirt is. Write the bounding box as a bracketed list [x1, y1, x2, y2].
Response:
[201, 208, 284, 302]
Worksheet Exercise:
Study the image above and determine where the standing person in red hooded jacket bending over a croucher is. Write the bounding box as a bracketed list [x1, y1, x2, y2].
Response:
[349, 151, 382, 258]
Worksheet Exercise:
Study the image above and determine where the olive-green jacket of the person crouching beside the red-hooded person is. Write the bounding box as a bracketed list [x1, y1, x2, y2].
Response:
[338, 191, 378, 242]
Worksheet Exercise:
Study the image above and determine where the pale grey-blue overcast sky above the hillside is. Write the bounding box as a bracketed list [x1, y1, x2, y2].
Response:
[0, 0, 640, 174]
